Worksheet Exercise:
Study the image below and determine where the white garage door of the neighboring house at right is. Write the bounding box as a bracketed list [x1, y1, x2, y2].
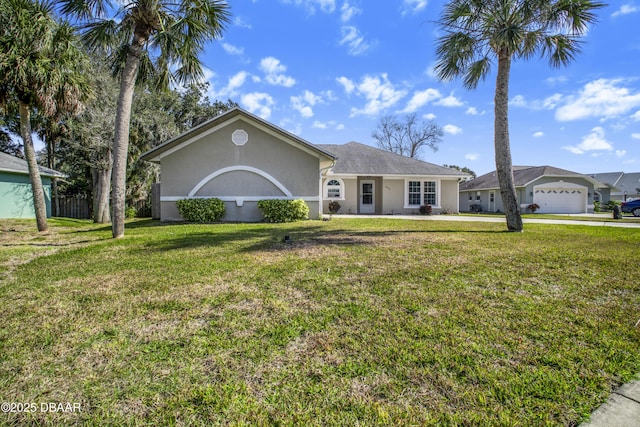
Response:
[533, 183, 587, 213]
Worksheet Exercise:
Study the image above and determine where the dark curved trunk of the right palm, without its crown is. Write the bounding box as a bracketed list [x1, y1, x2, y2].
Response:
[494, 50, 523, 231]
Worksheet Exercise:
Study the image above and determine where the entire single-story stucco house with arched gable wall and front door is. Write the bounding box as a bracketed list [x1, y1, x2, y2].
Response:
[142, 108, 466, 222]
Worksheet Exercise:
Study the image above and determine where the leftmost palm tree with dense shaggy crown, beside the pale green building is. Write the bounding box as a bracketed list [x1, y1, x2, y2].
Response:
[0, 0, 89, 231]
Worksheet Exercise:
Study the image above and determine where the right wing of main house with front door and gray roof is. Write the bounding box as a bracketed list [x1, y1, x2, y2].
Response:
[319, 142, 469, 215]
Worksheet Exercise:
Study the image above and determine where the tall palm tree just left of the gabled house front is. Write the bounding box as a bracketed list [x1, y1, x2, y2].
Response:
[59, 0, 229, 238]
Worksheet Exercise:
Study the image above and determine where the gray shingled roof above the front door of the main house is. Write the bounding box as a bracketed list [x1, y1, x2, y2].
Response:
[318, 142, 468, 177]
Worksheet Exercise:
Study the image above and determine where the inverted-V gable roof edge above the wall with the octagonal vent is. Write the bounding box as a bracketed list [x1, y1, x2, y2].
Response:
[141, 107, 335, 162]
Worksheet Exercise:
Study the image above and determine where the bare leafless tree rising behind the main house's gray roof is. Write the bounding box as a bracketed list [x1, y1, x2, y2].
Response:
[371, 113, 444, 158]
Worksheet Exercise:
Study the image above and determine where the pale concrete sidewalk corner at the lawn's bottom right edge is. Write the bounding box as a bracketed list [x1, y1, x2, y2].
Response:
[580, 380, 640, 427]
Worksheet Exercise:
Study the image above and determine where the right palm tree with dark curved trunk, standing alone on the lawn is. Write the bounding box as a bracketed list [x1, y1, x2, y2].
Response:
[435, 0, 605, 231]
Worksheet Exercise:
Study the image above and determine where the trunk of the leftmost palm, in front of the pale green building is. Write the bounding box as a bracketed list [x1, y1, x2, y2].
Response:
[19, 101, 49, 231]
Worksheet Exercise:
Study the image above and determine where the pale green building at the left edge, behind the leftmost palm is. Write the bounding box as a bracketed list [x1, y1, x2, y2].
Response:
[0, 152, 65, 218]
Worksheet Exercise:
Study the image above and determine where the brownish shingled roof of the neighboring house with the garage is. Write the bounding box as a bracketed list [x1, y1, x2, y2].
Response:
[460, 166, 603, 191]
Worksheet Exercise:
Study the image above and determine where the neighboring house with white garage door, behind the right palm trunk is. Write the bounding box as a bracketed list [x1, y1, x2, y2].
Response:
[460, 166, 608, 214]
